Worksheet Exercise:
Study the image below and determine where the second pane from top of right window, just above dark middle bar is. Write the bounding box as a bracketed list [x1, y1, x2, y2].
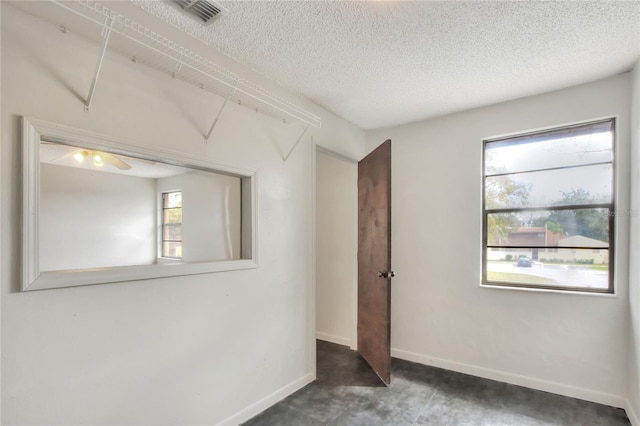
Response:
[485, 164, 613, 209]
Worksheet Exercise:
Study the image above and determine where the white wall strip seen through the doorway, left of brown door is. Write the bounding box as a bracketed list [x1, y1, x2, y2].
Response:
[316, 152, 358, 347]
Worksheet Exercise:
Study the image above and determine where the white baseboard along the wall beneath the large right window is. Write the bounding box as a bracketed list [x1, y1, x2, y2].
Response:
[391, 348, 624, 410]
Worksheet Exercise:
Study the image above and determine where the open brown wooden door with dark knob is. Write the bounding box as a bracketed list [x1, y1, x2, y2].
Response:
[358, 140, 391, 384]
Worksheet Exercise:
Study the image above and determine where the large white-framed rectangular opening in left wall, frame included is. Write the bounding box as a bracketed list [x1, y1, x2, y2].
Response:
[22, 117, 257, 291]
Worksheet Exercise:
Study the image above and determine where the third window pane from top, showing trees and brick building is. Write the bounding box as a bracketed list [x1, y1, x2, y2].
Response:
[487, 209, 609, 248]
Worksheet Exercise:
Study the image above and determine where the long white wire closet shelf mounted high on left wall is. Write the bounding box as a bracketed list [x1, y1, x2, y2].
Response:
[50, 0, 321, 128]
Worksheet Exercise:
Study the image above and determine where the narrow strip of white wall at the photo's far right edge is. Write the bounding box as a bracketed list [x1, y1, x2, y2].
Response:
[627, 62, 640, 426]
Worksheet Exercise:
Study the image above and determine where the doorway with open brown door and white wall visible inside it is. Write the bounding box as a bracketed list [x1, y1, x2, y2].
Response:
[315, 140, 394, 385]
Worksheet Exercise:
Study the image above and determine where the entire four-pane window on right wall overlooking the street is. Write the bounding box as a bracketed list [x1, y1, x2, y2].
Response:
[484, 120, 614, 292]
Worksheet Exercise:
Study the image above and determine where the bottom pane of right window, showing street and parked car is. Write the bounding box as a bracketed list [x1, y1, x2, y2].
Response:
[486, 248, 609, 290]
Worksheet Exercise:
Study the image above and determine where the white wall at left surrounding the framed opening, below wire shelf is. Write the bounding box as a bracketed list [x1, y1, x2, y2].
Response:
[0, 1, 364, 425]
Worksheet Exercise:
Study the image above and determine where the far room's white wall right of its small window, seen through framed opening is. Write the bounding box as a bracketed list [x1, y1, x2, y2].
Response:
[157, 172, 241, 262]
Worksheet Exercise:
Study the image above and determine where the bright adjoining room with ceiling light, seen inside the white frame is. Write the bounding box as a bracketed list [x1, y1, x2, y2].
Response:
[39, 141, 240, 271]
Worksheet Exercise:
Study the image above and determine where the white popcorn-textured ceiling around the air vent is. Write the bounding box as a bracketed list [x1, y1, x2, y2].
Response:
[132, 0, 640, 129]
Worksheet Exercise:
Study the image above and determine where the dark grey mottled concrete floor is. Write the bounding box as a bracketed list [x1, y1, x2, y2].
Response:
[245, 341, 630, 426]
